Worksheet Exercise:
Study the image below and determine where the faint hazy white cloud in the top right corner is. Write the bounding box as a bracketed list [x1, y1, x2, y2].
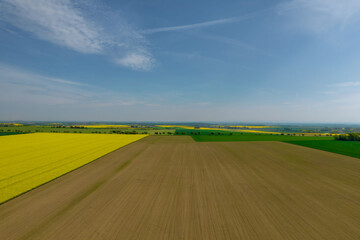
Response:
[278, 0, 360, 34]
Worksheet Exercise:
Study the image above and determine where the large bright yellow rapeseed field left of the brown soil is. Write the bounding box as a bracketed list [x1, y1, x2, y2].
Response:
[0, 133, 147, 203]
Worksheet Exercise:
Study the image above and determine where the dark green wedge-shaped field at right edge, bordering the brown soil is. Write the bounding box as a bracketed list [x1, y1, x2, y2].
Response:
[287, 140, 360, 158]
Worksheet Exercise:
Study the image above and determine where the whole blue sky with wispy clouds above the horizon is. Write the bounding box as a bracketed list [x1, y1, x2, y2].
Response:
[0, 0, 360, 123]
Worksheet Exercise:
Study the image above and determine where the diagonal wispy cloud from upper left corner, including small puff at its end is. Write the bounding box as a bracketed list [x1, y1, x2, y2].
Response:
[0, 0, 154, 70]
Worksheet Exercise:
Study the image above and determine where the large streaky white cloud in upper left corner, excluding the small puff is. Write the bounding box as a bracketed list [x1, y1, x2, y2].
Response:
[1, 0, 105, 53]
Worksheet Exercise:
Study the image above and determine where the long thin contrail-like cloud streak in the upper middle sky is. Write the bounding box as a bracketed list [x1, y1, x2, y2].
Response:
[141, 9, 269, 34]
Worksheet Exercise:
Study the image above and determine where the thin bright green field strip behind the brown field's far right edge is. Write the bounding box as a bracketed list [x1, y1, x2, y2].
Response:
[191, 133, 334, 142]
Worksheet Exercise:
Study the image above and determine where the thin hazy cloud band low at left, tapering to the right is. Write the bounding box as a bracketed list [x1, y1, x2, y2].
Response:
[0, 63, 153, 107]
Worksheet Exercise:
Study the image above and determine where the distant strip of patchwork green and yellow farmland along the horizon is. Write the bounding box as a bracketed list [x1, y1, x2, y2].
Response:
[0, 122, 352, 137]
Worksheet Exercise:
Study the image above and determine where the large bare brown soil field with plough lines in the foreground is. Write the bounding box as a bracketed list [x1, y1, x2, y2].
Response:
[0, 136, 360, 240]
